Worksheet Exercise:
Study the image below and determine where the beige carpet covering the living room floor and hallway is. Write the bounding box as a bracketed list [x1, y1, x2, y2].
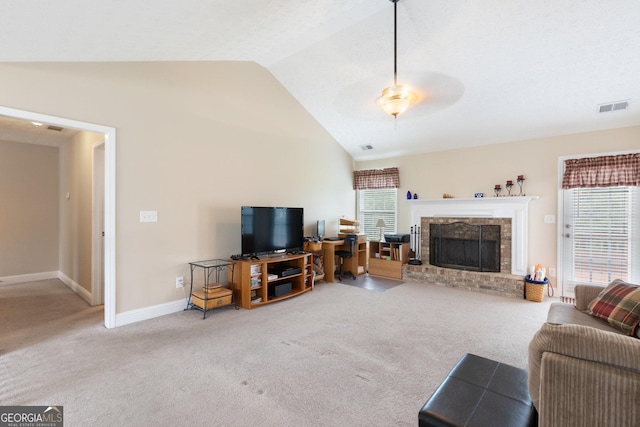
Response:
[0, 280, 549, 427]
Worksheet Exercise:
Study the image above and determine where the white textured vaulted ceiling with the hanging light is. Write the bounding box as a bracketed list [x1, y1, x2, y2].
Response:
[0, 0, 640, 160]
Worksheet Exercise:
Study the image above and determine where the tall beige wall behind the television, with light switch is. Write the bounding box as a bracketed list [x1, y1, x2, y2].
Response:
[0, 62, 355, 313]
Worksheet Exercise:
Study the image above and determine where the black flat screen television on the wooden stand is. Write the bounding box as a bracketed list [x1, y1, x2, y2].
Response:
[240, 206, 304, 255]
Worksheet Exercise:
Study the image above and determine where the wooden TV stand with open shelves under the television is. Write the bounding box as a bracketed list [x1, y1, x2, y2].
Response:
[233, 253, 313, 309]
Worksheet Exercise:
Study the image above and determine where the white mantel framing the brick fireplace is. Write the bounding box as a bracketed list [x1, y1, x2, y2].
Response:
[407, 196, 538, 276]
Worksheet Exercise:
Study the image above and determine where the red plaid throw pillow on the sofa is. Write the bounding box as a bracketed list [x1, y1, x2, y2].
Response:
[587, 280, 640, 336]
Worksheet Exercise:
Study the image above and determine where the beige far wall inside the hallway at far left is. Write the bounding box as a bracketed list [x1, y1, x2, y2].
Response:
[0, 141, 58, 277]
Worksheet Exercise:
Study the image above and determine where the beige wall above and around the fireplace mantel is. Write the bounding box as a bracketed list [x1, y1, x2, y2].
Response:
[356, 127, 640, 283]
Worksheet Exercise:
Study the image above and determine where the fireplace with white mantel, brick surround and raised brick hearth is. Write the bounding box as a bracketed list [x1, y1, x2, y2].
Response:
[403, 197, 537, 298]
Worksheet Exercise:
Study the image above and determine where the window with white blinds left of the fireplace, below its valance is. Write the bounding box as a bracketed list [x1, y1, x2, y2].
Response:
[358, 188, 398, 240]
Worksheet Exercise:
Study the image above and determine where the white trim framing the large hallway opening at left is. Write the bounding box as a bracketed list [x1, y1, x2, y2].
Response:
[0, 106, 116, 328]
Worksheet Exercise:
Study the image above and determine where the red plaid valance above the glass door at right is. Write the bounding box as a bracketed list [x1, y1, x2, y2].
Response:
[562, 153, 640, 189]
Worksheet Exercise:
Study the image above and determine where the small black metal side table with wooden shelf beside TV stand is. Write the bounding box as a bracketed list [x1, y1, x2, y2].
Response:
[185, 259, 238, 319]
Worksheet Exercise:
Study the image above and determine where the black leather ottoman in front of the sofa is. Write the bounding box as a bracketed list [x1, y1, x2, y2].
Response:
[418, 354, 538, 427]
